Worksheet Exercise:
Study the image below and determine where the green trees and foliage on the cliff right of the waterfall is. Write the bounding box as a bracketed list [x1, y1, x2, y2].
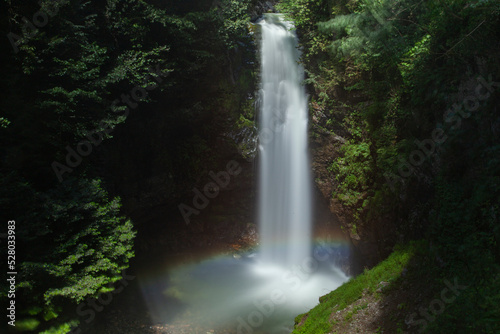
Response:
[286, 0, 500, 333]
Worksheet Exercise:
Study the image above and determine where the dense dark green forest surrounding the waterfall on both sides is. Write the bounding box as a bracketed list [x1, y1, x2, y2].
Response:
[0, 0, 500, 334]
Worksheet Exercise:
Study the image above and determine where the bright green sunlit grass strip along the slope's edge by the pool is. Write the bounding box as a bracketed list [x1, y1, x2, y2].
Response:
[292, 242, 420, 334]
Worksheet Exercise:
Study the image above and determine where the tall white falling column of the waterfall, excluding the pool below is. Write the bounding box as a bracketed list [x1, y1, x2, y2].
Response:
[258, 14, 311, 267]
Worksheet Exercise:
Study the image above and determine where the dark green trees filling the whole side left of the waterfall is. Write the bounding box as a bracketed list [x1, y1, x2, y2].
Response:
[0, 0, 256, 333]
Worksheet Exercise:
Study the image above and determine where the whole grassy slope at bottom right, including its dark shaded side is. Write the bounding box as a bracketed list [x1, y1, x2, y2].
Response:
[293, 241, 500, 334]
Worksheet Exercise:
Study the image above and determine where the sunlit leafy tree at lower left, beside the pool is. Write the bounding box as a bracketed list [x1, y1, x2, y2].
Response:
[1, 175, 135, 329]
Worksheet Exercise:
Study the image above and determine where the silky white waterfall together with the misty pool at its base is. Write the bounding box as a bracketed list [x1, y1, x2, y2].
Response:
[139, 14, 348, 334]
